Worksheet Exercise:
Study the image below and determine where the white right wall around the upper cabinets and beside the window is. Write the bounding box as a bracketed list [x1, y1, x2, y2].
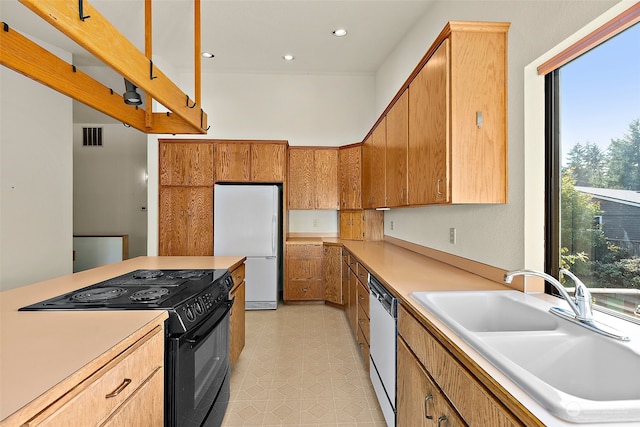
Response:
[376, 0, 618, 269]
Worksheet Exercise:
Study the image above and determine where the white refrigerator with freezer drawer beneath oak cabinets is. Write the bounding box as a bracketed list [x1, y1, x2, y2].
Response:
[213, 184, 281, 310]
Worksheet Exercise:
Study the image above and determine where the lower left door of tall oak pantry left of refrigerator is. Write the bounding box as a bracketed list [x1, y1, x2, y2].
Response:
[158, 187, 189, 256]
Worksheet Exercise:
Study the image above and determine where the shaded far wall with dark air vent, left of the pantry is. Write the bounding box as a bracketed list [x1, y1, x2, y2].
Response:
[73, 123, 147, 258]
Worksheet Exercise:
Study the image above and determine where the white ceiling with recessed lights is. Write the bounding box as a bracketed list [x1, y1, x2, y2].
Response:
[0, 0, 434, 123]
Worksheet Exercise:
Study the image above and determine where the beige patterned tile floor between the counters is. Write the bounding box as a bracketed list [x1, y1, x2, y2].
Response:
[222, 305, 386, 427]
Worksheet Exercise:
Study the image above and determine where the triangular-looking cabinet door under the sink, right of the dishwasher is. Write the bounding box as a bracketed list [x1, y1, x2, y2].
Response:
[396, 339, 466, 427]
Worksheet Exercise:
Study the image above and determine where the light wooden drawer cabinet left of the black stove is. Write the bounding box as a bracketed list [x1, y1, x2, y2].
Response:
[24, 325, 164, 427]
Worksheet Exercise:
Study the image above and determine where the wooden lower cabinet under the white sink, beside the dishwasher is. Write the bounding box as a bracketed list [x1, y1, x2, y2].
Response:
[397, 306, 523, 427]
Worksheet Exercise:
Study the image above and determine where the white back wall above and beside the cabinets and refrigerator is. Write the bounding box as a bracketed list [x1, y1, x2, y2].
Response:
[147, 74, 376, 255]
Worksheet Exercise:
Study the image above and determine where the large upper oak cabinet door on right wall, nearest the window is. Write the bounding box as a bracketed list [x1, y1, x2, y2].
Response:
[409, 39, 450, 205]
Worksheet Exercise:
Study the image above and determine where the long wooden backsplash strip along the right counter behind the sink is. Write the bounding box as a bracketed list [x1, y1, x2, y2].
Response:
[384, 234, 544, 292]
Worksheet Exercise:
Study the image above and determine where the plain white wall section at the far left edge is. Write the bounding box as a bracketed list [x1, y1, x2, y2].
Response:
[0, 48, 73, 290]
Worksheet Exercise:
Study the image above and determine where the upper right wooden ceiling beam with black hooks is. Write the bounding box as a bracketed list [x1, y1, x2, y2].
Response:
[20, 0, 208, 133]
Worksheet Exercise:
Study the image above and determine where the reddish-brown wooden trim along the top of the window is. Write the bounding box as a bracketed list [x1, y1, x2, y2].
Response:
[538, 2, 640, 75]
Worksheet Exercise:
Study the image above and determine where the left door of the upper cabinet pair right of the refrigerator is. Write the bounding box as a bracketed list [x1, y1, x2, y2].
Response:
[287, 148, 315, 209]
